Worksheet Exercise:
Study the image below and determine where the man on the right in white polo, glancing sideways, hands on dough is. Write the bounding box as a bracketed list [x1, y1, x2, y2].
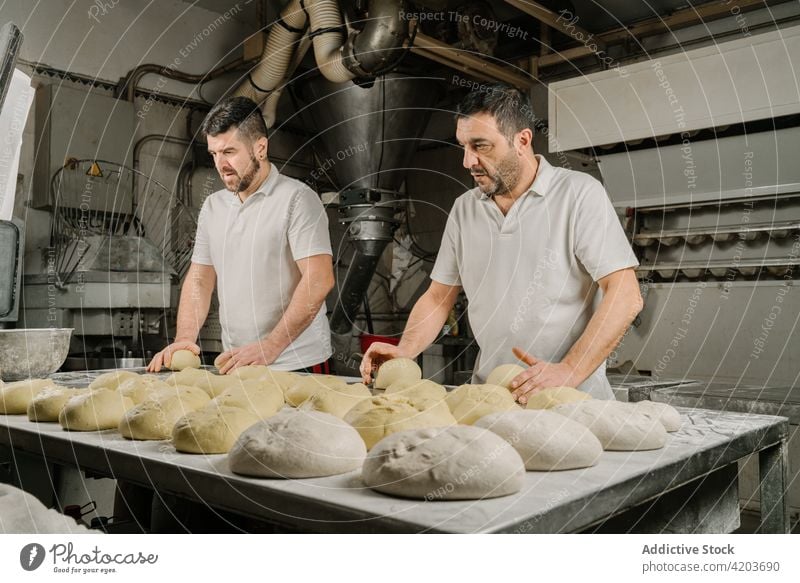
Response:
[361, 85, 642, 404]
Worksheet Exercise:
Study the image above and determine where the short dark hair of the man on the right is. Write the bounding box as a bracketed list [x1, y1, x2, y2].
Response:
[456, 83, 534, 142]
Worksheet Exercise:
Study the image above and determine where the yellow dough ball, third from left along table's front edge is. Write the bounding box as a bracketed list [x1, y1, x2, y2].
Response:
[58, 389, 133, 431]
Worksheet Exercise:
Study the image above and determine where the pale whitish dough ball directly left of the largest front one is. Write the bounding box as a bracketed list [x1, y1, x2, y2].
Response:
[228, 409, 367, 478]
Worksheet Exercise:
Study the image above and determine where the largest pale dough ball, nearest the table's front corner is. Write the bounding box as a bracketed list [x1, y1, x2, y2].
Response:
[361, 424, 525, 500]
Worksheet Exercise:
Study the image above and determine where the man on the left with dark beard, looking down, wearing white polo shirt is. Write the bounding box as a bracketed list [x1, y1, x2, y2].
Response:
[148, 97, 334, 374]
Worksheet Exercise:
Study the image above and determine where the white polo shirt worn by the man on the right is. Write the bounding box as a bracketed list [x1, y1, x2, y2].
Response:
[431, 155, 638, 399]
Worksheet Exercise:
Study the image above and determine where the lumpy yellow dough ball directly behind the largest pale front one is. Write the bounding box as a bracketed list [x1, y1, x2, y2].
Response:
[351, 396, 455, 449]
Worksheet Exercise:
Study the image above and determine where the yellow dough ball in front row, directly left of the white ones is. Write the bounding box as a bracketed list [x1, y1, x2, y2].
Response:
[172, 406, 258, 454]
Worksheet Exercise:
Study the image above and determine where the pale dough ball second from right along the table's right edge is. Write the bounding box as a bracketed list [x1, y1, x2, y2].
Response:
[551, 399, 667, 451]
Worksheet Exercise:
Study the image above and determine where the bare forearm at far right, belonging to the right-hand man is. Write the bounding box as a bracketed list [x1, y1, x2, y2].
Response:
[561, 280, 642, 382]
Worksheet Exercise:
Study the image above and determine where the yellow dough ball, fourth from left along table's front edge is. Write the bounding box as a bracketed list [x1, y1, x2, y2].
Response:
[118, 387, 209, 440]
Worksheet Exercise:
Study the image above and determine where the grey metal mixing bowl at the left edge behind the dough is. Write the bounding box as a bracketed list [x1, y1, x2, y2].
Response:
[0, 328, 74, 381]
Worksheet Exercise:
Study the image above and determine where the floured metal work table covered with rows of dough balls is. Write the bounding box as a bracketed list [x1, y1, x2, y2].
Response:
[0, 409, 788, 533]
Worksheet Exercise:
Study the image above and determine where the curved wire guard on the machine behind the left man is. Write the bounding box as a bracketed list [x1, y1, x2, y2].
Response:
[49, 159, 197, 287]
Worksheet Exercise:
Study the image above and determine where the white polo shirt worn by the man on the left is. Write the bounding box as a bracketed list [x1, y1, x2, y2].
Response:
[192, 165, 333, 370]
